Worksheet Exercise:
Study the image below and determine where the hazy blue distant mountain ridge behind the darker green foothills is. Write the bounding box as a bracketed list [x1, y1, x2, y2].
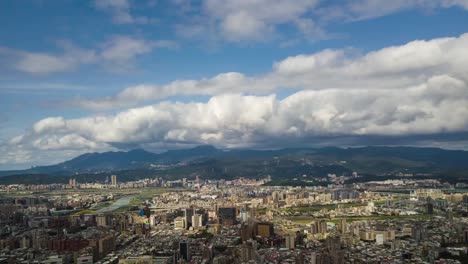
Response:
[0, 145, 468, 177]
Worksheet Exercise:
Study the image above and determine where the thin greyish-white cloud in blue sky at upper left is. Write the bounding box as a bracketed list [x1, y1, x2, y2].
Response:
[0, 35, 177, 75]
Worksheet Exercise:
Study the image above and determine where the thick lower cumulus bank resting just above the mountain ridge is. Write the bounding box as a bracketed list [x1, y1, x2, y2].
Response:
[6, 75, 468, 157]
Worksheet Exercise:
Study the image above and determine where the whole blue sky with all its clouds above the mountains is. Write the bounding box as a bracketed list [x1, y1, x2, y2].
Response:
[0, 0, 468, 169]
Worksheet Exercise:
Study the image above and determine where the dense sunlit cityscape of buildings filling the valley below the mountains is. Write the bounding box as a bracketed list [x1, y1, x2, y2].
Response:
[0, 172, 468, 264]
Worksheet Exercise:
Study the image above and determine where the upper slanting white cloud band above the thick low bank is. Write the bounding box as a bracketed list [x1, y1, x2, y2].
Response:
[73, 34, 468, 110]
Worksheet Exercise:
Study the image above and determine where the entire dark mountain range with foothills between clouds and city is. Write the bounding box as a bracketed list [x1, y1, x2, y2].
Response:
[0, 145, 468, 183]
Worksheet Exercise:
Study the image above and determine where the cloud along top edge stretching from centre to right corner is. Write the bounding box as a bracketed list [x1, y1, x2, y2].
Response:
[173, 0, 468, 42]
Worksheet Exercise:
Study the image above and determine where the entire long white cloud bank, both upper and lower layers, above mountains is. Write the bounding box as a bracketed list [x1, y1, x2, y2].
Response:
[0, 34, 468, 167]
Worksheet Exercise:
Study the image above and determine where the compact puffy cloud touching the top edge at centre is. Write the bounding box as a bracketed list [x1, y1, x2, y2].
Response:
[176, 0, 323, 42]
